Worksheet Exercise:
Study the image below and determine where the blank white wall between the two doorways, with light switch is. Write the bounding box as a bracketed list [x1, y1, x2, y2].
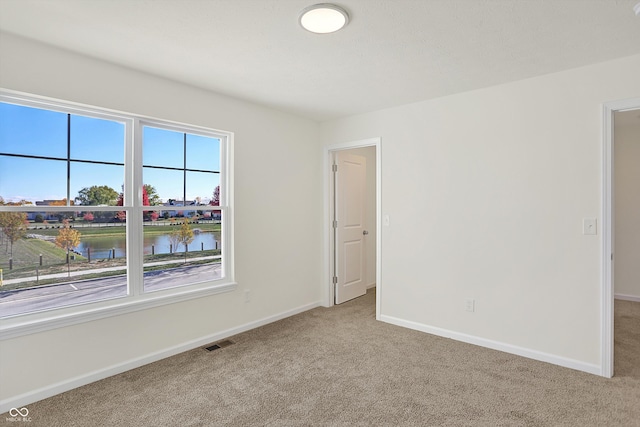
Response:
[321, 55, 640, 373]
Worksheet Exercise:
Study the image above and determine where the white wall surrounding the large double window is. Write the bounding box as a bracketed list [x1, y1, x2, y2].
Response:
[0, 34, 323, 412]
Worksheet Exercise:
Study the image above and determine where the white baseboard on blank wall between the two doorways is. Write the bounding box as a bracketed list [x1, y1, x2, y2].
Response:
[379, 315, 602, 376]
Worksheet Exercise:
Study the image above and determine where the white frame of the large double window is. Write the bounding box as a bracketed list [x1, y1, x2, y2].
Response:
[0, 89, 237, 340]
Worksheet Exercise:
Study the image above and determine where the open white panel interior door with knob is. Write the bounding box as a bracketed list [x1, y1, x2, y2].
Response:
[333, 151, 368, 304]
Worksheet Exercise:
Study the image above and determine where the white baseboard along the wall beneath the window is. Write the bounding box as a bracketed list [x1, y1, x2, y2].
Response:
[0, 301, 321, 414]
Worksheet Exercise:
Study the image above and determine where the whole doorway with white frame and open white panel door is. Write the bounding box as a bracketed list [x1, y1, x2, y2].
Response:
[324, 138, 382, 317]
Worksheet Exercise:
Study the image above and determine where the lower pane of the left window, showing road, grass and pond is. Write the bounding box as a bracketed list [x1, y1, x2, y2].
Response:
[0, 211, 127, 317]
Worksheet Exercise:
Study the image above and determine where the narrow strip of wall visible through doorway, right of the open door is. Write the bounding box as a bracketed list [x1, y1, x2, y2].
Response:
[348, 146, 377, 287]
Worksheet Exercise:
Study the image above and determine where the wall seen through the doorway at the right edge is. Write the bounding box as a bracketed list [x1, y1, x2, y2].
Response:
[613, 110, 640, 301]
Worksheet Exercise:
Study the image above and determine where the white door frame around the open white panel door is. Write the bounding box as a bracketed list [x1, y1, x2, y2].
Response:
[322, 137, 382, 319]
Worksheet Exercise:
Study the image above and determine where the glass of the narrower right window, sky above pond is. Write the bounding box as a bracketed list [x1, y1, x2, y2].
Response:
[142, 124, 225, 292]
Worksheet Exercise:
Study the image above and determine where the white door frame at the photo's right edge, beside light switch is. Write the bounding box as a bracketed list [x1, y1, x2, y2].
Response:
[600, 98, 640, 378]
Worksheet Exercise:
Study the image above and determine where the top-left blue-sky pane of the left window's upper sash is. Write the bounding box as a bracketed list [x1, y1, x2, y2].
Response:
[0, 103, 67, 159]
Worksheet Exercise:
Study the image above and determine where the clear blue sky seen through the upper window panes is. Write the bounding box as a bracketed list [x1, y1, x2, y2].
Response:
[0, 103, 220, 202]
